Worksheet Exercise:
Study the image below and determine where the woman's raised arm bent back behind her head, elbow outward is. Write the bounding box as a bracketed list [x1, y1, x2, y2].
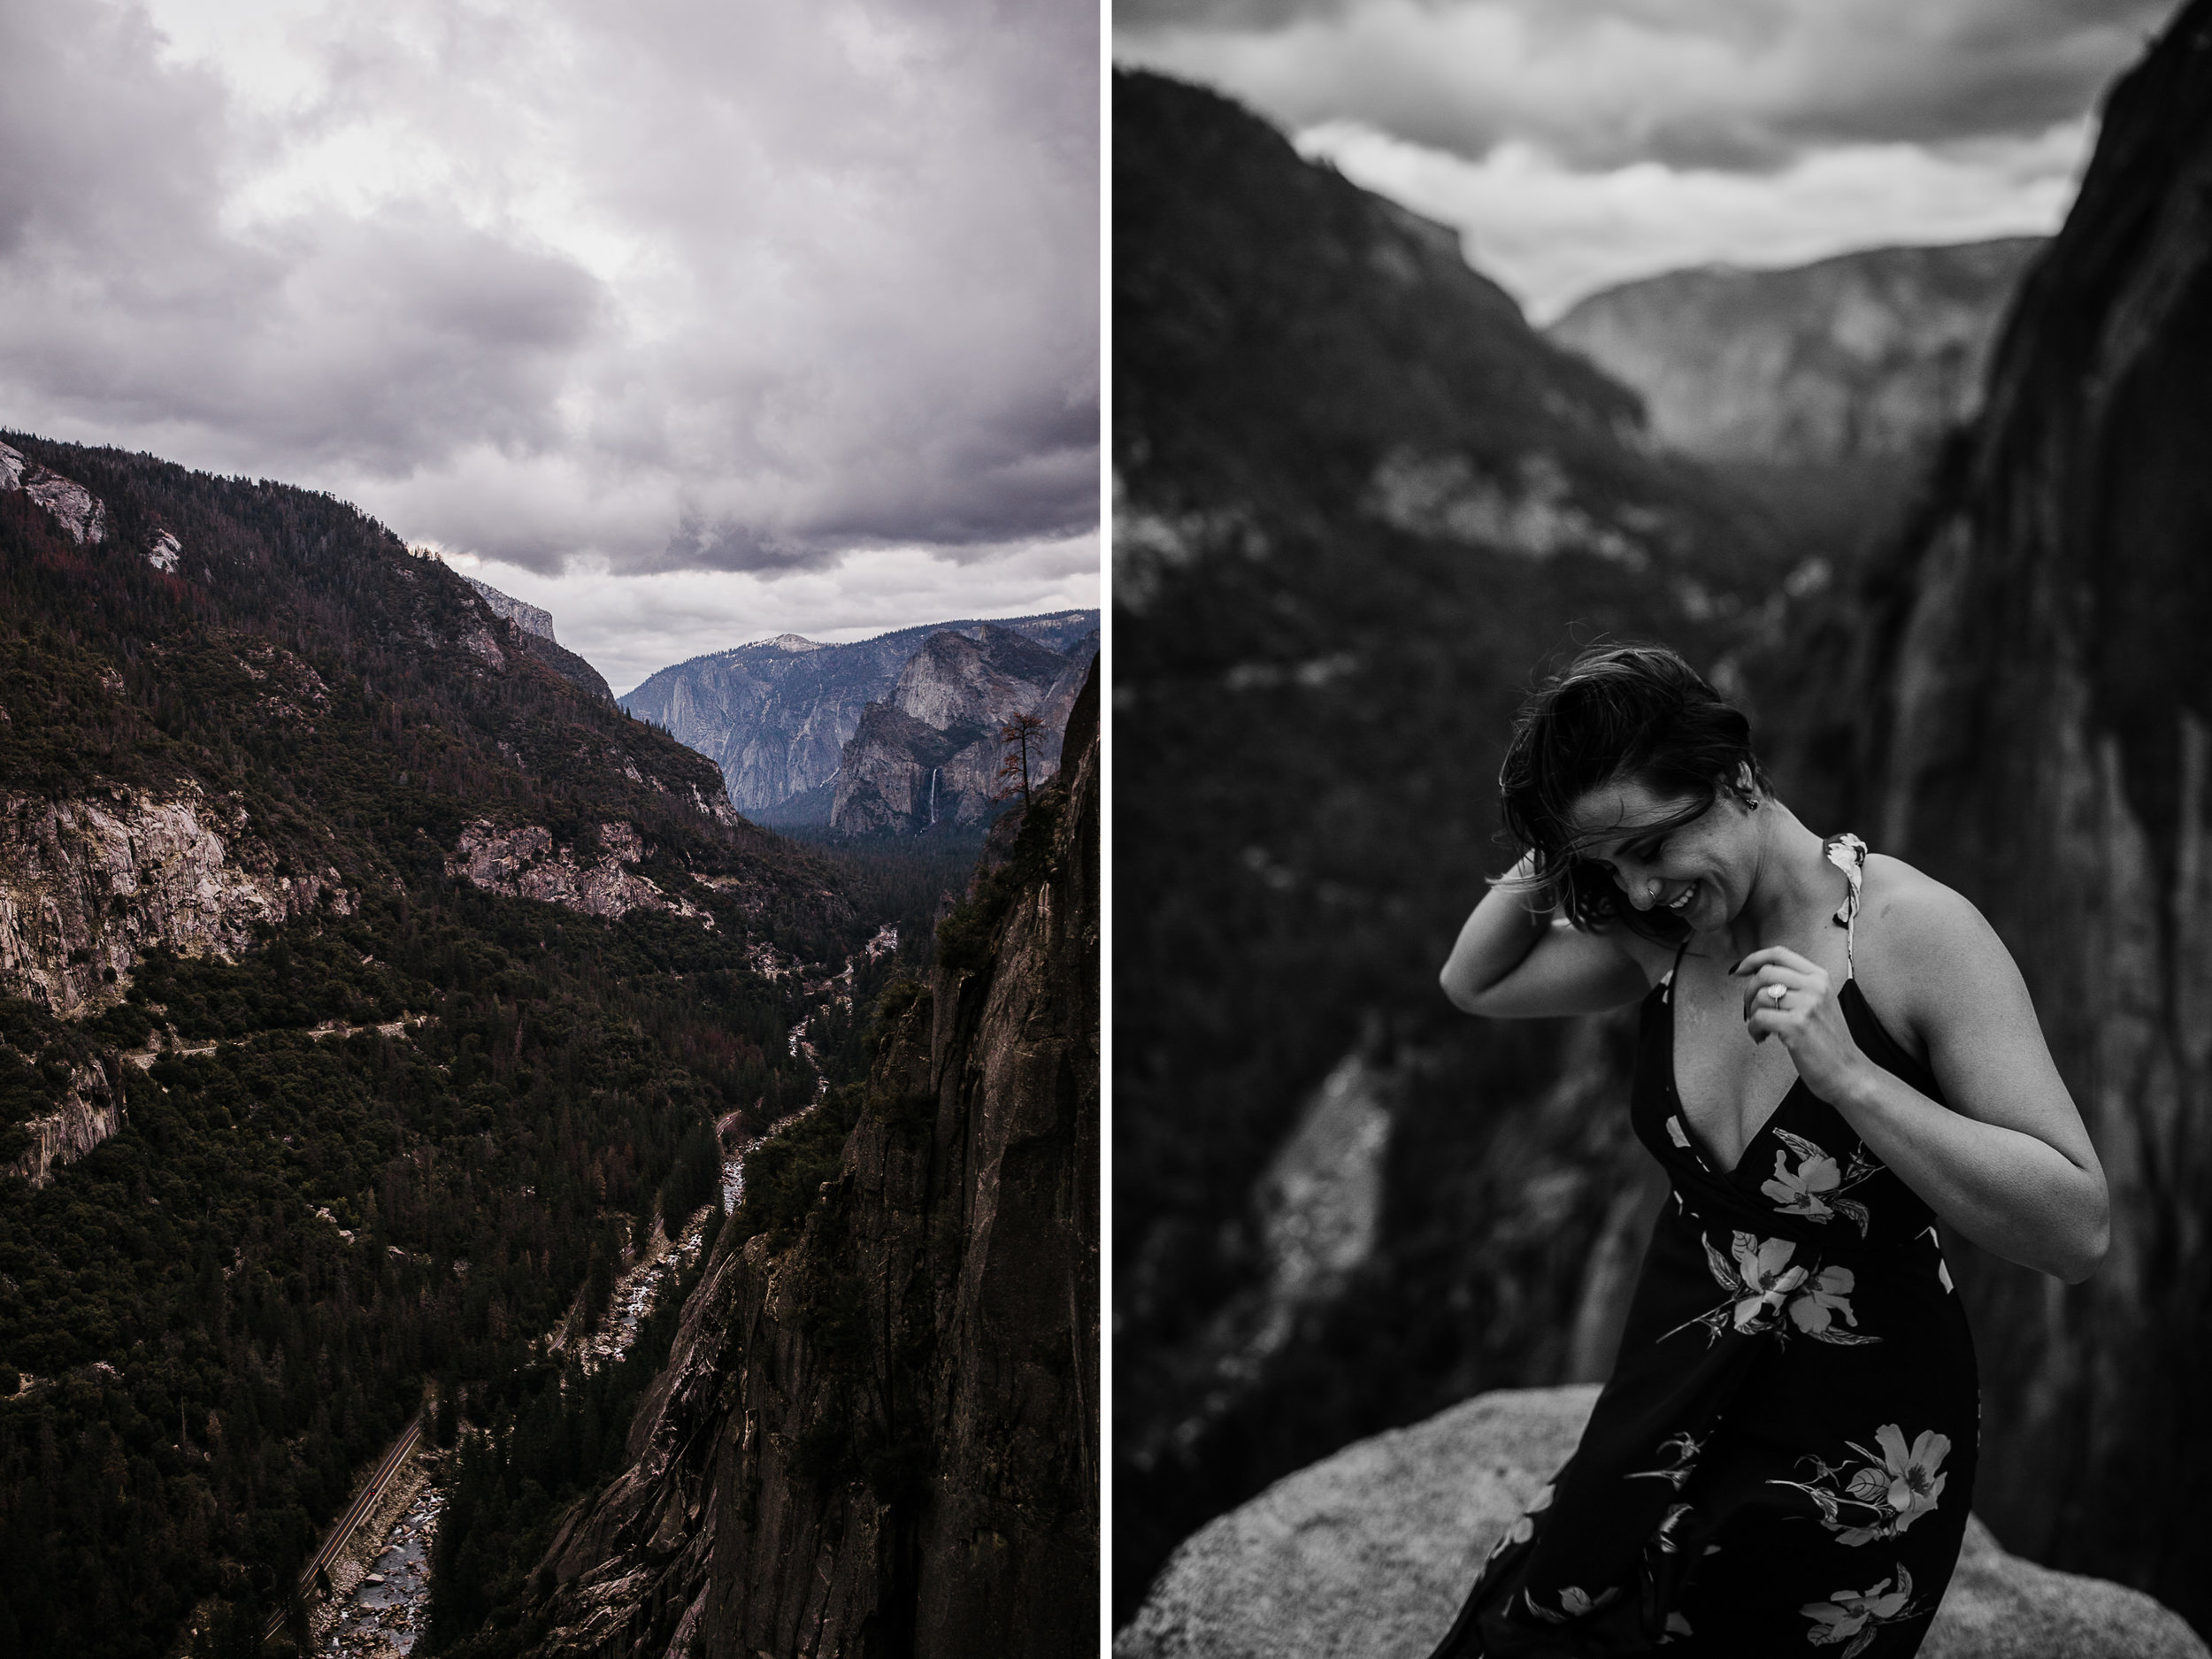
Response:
[1438, 858, 1646, 1020]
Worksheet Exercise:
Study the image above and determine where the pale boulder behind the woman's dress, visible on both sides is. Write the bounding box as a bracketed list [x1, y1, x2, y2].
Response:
[1113, 1387, 2208, 1659]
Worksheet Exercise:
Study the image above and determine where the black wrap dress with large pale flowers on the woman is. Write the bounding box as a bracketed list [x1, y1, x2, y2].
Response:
[1436, 836, 1980, 1659]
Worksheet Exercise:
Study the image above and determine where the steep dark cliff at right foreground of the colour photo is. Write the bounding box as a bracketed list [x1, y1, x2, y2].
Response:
[534, 668, 1100, 1659]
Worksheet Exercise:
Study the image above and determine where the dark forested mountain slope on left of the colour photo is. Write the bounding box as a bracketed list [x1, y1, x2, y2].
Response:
[0, 434, 896, 1655]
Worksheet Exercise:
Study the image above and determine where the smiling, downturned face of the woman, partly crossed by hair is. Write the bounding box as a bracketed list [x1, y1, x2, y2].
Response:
[1569, 779, 1759, 933]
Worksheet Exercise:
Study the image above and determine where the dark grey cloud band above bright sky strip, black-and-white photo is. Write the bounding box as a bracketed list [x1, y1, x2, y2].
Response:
[1118, 0, 2175, 171]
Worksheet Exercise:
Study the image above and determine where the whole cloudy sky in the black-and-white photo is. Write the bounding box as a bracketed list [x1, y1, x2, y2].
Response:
[1115, 0, 2179, 321]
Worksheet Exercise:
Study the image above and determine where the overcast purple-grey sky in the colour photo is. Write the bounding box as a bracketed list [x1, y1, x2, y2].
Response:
[0, 0, 1100, 690]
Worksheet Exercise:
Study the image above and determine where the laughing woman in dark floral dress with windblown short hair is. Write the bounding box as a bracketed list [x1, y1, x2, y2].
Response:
[1438, 646, 2108, 1659]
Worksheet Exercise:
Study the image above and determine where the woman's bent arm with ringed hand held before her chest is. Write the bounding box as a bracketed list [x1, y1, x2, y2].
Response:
[1737, 879, 2110, 1283]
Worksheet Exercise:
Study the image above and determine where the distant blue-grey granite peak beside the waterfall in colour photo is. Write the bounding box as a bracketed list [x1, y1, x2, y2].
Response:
[830, 624, 1097, 834]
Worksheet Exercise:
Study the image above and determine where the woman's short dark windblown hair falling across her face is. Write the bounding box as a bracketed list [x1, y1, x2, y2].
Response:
[1498, 646, 1770, 945]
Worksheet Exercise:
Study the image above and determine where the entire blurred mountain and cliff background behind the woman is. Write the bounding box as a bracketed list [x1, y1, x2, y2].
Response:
[1113, 3, 2212, 1628]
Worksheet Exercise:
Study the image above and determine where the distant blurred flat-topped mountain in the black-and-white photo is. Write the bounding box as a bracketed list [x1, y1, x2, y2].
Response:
[1547, 237, 2044, 463]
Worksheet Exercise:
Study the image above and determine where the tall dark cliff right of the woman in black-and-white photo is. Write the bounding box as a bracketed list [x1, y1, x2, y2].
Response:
[1809, 0, 2212, 1628]
